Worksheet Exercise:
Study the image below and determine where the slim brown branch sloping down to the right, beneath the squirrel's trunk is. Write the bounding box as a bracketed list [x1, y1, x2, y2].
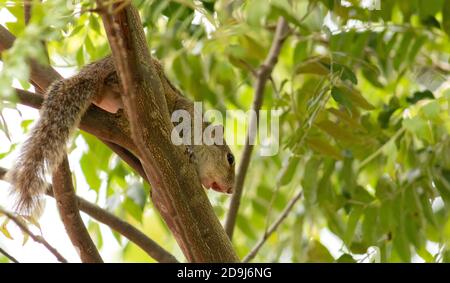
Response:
[0, 167, 178, 262]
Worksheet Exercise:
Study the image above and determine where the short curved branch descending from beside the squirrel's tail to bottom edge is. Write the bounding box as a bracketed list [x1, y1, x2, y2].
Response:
[52, 156, 103, 263]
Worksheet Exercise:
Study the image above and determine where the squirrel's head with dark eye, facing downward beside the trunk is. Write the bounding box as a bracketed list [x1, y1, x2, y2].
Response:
[193, 125, 236, 194]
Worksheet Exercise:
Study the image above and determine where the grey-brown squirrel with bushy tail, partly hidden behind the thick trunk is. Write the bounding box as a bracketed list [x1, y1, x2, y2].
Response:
[6, 56, 235, 216]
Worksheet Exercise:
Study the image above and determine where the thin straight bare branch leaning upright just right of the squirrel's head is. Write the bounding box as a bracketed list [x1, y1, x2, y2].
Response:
[225, 17, 288, 239]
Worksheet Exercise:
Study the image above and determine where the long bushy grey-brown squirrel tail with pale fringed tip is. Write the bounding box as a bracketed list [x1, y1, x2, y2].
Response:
[6, 76, 98, 216]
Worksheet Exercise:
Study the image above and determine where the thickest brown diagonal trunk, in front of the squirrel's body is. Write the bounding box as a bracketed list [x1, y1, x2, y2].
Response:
[97, 0, 238, 262]
